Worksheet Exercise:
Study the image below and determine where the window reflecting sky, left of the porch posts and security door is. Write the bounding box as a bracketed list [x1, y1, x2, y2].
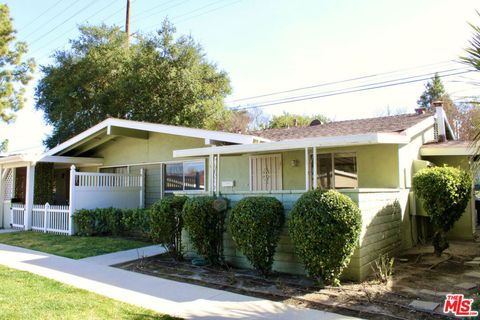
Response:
[164, 161, 205, 193]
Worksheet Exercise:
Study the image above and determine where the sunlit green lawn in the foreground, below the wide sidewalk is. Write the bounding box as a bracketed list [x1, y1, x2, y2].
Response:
[0, 266, 175, 320]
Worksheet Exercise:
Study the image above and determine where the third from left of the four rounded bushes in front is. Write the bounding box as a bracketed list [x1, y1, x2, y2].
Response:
[229, 197, 285, 275]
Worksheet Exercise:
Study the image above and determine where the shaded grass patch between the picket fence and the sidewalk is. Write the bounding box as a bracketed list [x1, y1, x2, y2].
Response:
[0, 231, 151, 259]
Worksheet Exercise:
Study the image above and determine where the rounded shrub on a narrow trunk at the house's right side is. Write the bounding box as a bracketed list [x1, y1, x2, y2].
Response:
[413, 166, 472, 256]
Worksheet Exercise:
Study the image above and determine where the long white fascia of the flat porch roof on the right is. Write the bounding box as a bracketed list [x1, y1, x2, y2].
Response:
[173, 133, 410, 158]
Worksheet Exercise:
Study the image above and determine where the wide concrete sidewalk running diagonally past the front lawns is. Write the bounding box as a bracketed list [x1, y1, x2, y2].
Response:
[0, 244, 354, 320]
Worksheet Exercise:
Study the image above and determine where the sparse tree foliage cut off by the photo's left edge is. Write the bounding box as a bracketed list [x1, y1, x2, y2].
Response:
[0, 4, 35, 151]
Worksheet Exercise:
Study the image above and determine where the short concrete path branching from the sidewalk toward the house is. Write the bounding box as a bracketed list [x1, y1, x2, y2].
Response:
[80, 245, 165, 266]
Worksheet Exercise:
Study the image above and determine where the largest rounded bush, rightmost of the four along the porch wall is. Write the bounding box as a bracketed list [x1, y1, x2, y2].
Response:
[288, 190, 362, 285]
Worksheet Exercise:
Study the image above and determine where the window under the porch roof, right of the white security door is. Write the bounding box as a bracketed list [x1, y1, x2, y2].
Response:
[312, 152, 358, 189]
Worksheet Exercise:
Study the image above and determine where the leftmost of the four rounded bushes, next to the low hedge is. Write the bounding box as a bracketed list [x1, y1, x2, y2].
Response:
[150, 196, 188, 259]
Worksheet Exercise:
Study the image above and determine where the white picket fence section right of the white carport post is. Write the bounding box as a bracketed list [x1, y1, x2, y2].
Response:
[32, 203, 70, 235]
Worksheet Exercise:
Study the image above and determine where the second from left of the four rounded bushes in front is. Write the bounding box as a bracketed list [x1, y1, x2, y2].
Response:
[182, 196, 229, 264]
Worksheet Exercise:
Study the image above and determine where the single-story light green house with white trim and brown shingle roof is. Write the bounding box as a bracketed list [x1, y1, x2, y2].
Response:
[0, 107, 477, 280]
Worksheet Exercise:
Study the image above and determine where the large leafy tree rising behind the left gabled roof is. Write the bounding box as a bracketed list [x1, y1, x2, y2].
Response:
[36, 21, 230, 147]
